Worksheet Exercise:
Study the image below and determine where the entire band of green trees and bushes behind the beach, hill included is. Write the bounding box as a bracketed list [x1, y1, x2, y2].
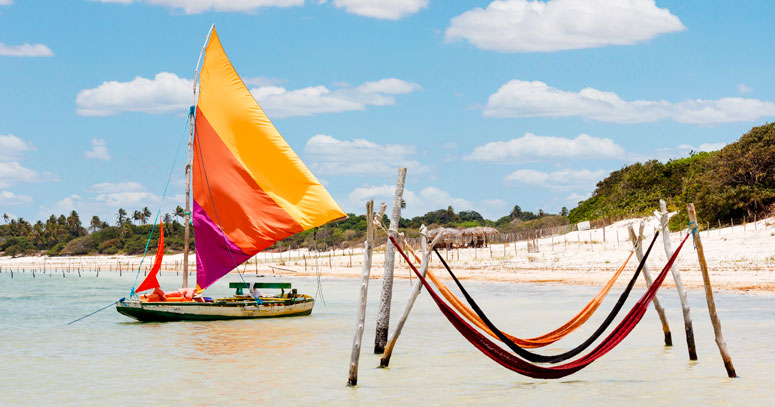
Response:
[0, 123, 775, 256]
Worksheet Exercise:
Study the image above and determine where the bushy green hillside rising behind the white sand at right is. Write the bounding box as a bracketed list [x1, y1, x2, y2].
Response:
[568, 123, 775, 229]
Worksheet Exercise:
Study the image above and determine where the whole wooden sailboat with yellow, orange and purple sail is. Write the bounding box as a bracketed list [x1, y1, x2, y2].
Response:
[116, 26, 347, 321]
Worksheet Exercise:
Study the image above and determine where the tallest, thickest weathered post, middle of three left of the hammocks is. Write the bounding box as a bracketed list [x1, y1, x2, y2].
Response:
[374, 167, 406, 354]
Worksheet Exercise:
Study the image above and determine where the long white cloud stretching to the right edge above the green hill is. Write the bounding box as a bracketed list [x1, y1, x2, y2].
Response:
[484, 80, 775, 124]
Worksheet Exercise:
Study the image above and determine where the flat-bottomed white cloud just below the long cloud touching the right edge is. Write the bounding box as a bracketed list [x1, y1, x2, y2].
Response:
[463, 133, 625, 161]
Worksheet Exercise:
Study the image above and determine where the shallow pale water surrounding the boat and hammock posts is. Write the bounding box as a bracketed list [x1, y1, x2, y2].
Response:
[0, 270, 775, 406]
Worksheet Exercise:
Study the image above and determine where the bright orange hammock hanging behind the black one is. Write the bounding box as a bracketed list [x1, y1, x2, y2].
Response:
[404, 240, 633, 348]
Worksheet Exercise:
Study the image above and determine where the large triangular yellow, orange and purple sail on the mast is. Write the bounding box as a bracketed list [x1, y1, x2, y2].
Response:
[193, 29, 346, 288]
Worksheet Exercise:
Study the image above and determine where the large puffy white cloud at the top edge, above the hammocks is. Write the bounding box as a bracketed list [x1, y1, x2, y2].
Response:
[446, 0, 686, 52]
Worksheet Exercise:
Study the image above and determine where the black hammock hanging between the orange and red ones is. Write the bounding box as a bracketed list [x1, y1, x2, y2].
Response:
[436, 232, 659, 363]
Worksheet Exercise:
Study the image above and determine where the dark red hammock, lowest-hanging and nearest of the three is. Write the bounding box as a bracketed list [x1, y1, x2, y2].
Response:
[389, 234, 689, 379]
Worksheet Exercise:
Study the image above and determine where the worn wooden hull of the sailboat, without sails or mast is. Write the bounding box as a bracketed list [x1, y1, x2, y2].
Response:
[116, 298, 315, 322]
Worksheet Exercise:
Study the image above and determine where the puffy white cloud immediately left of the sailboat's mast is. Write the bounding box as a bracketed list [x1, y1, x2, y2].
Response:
[75, 72, 194, 116]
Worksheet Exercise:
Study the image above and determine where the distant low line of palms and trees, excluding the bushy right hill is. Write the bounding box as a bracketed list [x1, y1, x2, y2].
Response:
[0, 205, 568, 256]
